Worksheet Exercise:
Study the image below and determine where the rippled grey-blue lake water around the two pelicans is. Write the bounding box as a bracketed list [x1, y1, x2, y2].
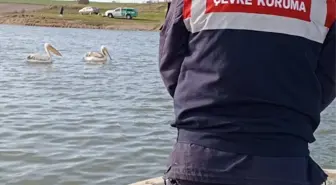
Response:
[0, 25, 336, 185]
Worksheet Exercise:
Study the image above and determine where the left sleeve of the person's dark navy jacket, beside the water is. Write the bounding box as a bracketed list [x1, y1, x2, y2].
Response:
[159, 0, 189, 97]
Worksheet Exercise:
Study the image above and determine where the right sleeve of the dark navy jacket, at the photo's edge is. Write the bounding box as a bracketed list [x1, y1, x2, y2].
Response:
[316, 22, 336, 112]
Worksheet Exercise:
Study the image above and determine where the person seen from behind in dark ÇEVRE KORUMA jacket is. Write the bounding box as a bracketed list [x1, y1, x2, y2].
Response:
[159, 0, 336, 185]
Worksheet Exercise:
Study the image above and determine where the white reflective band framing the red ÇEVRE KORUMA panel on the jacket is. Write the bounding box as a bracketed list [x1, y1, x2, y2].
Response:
[185, 0, 329, 43]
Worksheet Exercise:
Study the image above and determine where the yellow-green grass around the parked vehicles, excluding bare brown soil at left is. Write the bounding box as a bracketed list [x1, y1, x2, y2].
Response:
[0, 0, 167, 29]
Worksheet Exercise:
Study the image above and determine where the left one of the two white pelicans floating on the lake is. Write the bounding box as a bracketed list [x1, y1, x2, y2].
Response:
[27, 43, 62, 63]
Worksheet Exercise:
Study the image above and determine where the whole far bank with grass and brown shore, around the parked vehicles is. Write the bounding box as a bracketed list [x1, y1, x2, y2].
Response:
[0, 0, 167, 31]
